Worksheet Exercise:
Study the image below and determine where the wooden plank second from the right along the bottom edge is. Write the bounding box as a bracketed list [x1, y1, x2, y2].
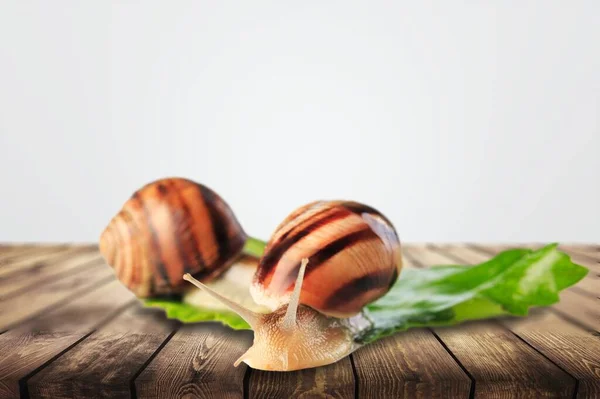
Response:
[415, 248, 575, 398]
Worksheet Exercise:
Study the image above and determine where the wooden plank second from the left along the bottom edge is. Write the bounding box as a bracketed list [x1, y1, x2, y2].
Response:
[27, 303, 179, 398]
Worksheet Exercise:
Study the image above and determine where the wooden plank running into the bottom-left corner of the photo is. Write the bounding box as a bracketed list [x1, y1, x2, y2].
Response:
[0, 281, 134, 399]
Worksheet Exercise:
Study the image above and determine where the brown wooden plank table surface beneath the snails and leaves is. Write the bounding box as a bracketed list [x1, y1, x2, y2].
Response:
[0, 245, 600, 398]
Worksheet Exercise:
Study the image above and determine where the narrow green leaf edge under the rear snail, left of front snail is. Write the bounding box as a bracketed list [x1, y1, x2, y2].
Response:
[144, 299, 250, 330]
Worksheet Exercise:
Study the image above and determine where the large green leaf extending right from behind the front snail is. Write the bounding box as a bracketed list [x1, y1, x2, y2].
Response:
[359, 244, 588, 343]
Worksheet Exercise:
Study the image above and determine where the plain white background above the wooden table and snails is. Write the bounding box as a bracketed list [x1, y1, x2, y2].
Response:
[0, 0, 600, 242]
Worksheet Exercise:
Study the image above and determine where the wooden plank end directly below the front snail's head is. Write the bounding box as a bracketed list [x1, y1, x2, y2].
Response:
[249, 357, 354, 399]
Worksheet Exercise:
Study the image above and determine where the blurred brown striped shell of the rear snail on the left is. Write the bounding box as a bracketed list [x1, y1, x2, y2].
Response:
[100, 178, 246, 298]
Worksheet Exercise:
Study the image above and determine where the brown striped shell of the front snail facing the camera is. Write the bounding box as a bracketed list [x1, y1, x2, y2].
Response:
[251, 201, 402, 317]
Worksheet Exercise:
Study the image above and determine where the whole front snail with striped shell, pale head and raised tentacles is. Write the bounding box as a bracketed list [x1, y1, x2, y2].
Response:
[183, 201, 402, 371]
